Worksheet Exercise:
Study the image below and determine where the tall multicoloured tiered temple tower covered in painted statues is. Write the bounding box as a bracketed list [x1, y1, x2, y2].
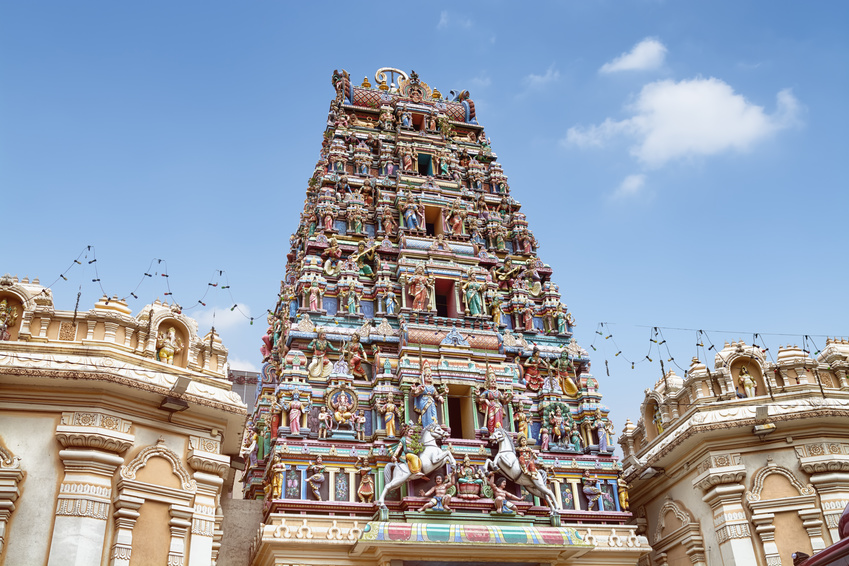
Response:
[243, 68, 648, 564]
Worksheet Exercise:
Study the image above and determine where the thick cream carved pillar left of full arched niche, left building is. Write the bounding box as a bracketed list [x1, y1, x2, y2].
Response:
[47, 412, 134, 566]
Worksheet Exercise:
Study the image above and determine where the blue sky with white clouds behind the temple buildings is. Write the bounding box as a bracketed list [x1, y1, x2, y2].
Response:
[0, 1, 849, 430]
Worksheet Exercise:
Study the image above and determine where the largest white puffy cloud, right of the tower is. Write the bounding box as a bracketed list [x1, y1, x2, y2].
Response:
[563, 78, 800, 167]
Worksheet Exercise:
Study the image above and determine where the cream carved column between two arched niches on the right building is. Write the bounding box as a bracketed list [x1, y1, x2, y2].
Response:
[693, 454, 758, 566]
